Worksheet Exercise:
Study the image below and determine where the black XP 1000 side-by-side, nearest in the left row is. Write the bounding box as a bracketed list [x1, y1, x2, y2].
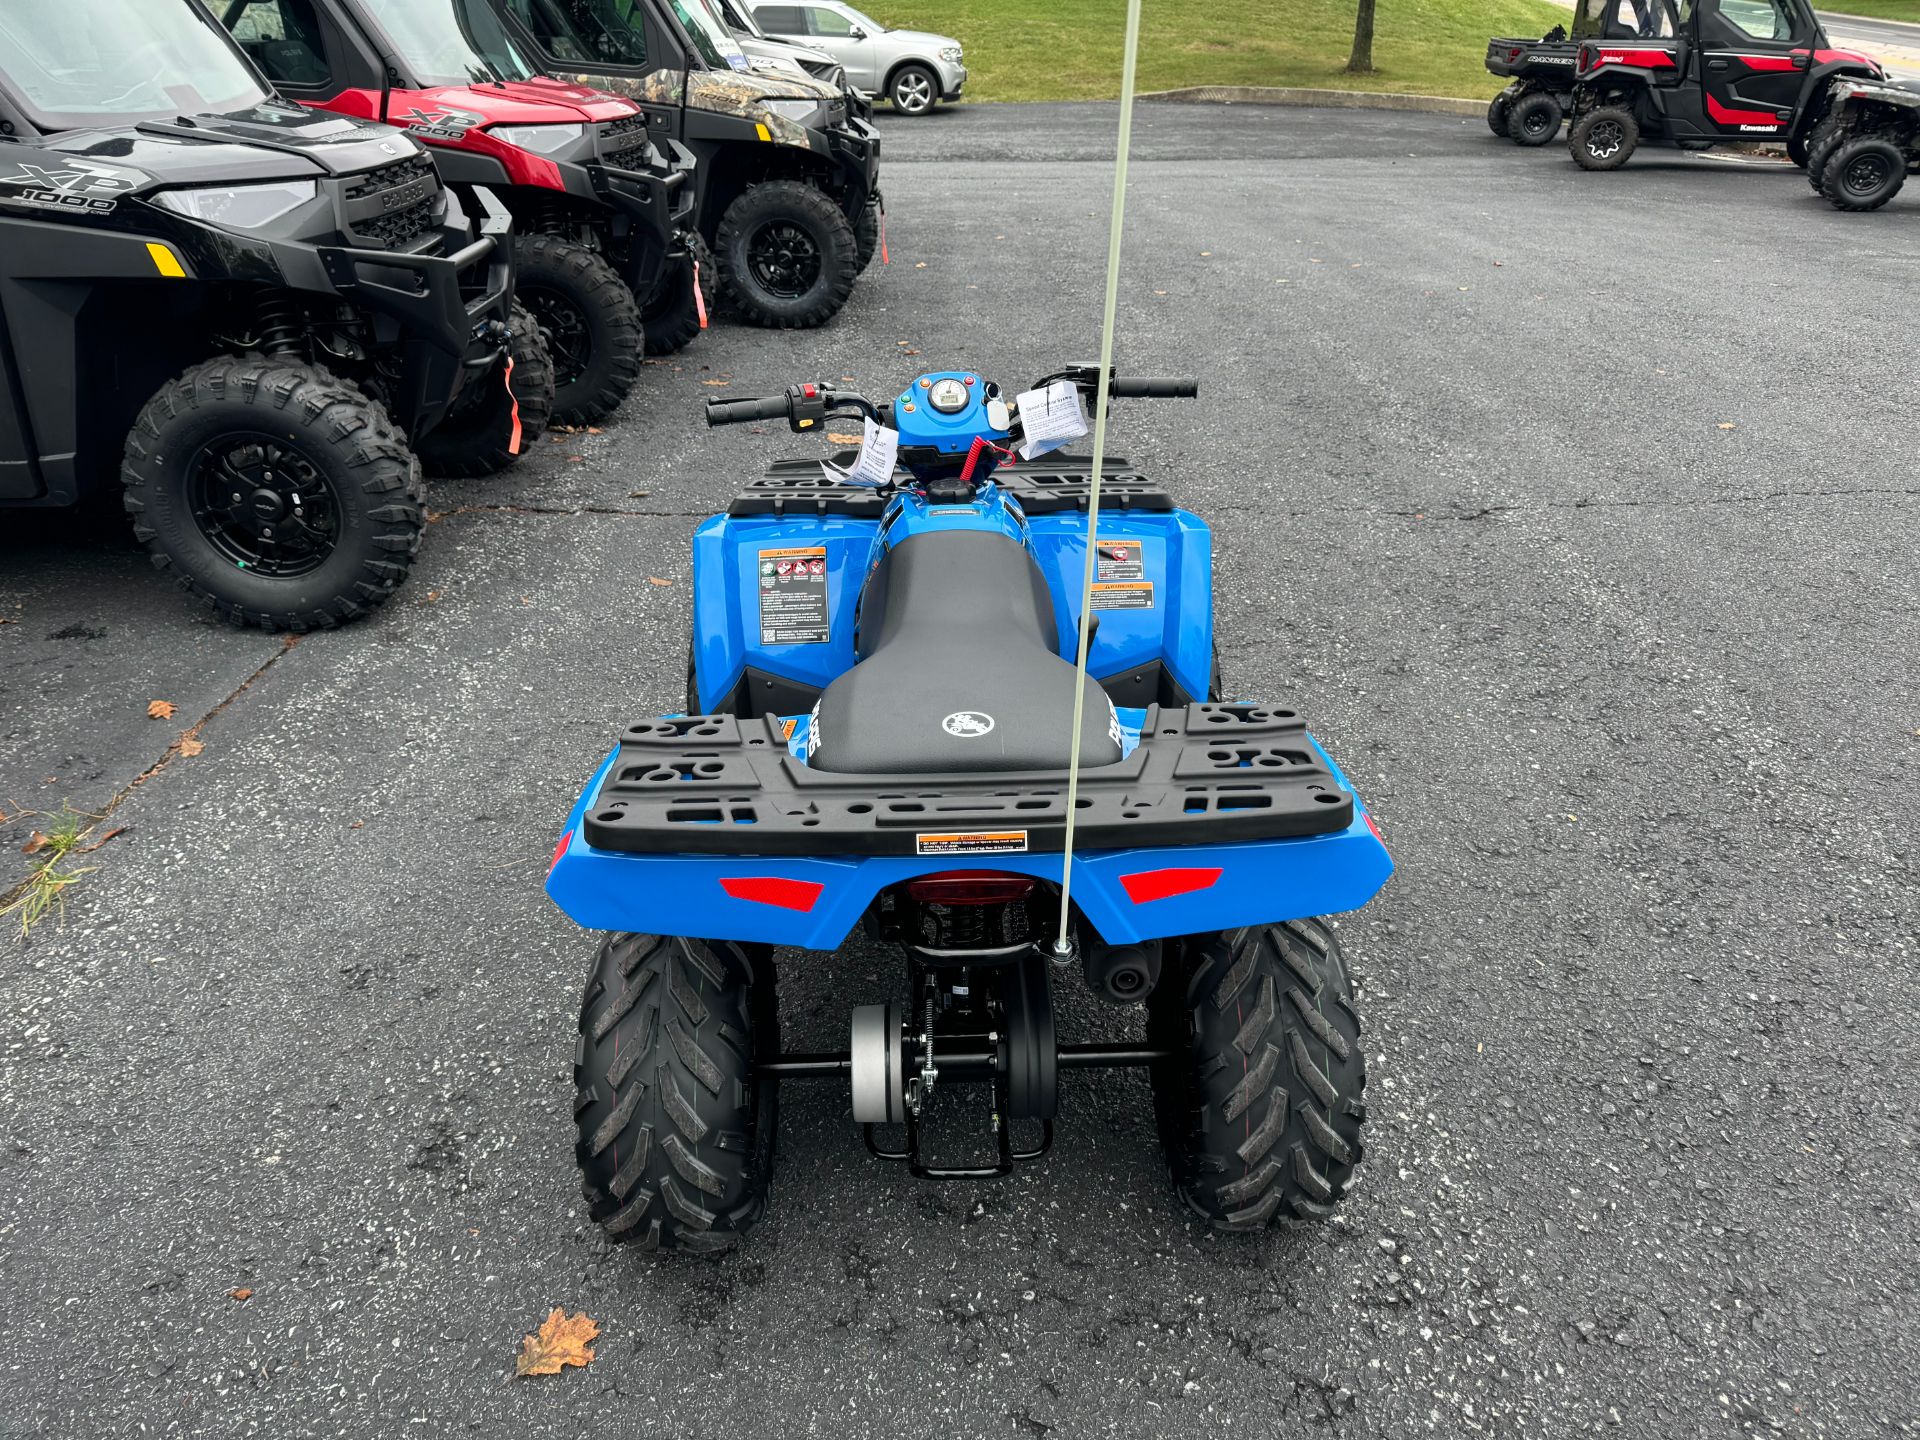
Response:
[0, 0, 551, 630]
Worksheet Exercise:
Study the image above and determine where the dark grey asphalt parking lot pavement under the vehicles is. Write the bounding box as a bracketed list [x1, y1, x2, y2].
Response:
[0, 106, 1920, 1440]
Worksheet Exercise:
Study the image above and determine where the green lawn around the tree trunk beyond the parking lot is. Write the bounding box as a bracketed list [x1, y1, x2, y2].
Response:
[862, 0, 1574, 100]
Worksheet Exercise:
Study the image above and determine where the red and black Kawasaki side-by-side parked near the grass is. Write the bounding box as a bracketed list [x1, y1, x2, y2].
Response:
[1567, 0, 1885, 171]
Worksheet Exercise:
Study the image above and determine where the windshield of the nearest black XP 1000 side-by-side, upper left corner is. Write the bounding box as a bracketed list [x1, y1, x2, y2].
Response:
[0, 0, 267, 131]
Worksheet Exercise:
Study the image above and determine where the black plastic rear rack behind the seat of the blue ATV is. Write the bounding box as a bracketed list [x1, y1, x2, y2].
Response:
[582, 705, 1354, 860]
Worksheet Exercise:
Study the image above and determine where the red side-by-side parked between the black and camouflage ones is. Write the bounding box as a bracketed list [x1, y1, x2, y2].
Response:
[207, 0, 703, 424]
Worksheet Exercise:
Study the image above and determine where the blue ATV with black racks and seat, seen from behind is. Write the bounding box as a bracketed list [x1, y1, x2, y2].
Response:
[547, 367, 1392, 1252]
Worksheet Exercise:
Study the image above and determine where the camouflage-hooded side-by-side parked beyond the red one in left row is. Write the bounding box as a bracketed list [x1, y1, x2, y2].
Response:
[493, 0, 881, 328]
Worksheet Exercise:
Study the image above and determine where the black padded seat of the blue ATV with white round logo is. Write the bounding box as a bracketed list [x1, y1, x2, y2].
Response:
[808, 530, 1119, 776]
